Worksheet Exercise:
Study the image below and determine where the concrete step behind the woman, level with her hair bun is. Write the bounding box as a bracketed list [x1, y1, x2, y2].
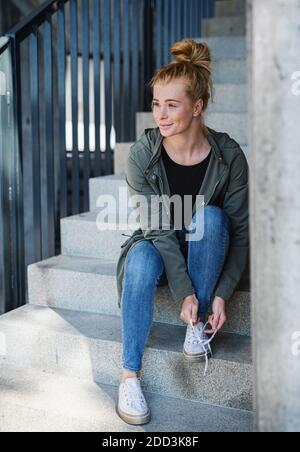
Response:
[194, 36, 247, 61]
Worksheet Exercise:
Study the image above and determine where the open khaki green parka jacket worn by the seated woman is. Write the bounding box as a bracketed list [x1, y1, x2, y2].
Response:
[116, 127, 249, 307]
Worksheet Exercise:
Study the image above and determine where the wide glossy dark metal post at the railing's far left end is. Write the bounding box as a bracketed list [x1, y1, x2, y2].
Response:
[0, 38, 25, 314]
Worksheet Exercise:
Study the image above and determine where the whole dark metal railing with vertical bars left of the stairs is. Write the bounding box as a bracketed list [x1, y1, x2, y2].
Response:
[0, 0, 214, 311]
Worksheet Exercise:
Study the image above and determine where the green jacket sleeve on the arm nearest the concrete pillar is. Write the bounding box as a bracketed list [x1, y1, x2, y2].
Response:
[215, 150, 249, 300]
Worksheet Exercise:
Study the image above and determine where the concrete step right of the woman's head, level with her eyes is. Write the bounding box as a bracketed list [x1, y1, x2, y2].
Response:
[207, 83, 248, 113]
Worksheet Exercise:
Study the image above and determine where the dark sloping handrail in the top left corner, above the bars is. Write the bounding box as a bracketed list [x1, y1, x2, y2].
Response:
[5, 0, 68, 42]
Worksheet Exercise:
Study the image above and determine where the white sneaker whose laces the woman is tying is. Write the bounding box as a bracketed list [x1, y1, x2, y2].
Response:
[183, 321, 217, 375]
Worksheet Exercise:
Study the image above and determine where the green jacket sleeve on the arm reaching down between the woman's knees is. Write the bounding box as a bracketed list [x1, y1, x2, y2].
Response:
[126, 152, 195, 302]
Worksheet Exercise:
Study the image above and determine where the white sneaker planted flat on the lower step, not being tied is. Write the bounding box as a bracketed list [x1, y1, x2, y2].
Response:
[116, 377, 150, 425]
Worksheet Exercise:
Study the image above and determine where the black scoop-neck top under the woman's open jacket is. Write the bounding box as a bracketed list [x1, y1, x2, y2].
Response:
[162, 146, 212, 230]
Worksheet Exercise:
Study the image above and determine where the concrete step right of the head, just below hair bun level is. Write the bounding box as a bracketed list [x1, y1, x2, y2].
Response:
[213, 58, 247, 85]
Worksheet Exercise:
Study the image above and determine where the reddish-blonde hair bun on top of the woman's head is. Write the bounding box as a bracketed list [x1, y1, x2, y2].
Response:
[171, 39, 211, 73]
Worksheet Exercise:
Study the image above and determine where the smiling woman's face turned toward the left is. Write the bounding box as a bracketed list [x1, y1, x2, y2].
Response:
[152, 79, 203, 137]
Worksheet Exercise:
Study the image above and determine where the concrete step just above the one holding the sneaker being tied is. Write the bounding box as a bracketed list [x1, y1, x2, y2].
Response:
[28, 255, 251, 335]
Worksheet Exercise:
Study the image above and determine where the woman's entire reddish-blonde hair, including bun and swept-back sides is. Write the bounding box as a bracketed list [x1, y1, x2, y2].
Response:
[149, 39, 213, 133]
